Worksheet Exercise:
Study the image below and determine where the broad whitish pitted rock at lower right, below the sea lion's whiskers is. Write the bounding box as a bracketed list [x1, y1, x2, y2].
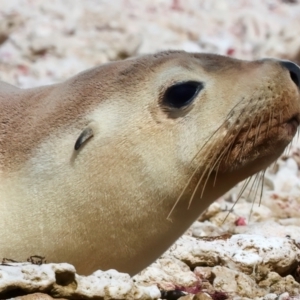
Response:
[167, 234, 300, 280]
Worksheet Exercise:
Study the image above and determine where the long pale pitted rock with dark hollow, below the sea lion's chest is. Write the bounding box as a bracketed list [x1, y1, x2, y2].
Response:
[0, 263, 160, 300]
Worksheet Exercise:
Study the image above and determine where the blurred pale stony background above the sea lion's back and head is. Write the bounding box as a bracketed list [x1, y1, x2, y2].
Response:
[0, 0, 300, 87]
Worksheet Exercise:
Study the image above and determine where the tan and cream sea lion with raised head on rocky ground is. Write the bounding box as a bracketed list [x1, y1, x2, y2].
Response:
[0, 51, 300, 274]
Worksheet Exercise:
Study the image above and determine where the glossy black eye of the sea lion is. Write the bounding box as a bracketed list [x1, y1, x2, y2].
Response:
[163, 81, 204, 108]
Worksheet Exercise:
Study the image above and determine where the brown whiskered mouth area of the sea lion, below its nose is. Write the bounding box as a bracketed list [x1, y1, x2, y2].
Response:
[211, 108, 300, 173]
